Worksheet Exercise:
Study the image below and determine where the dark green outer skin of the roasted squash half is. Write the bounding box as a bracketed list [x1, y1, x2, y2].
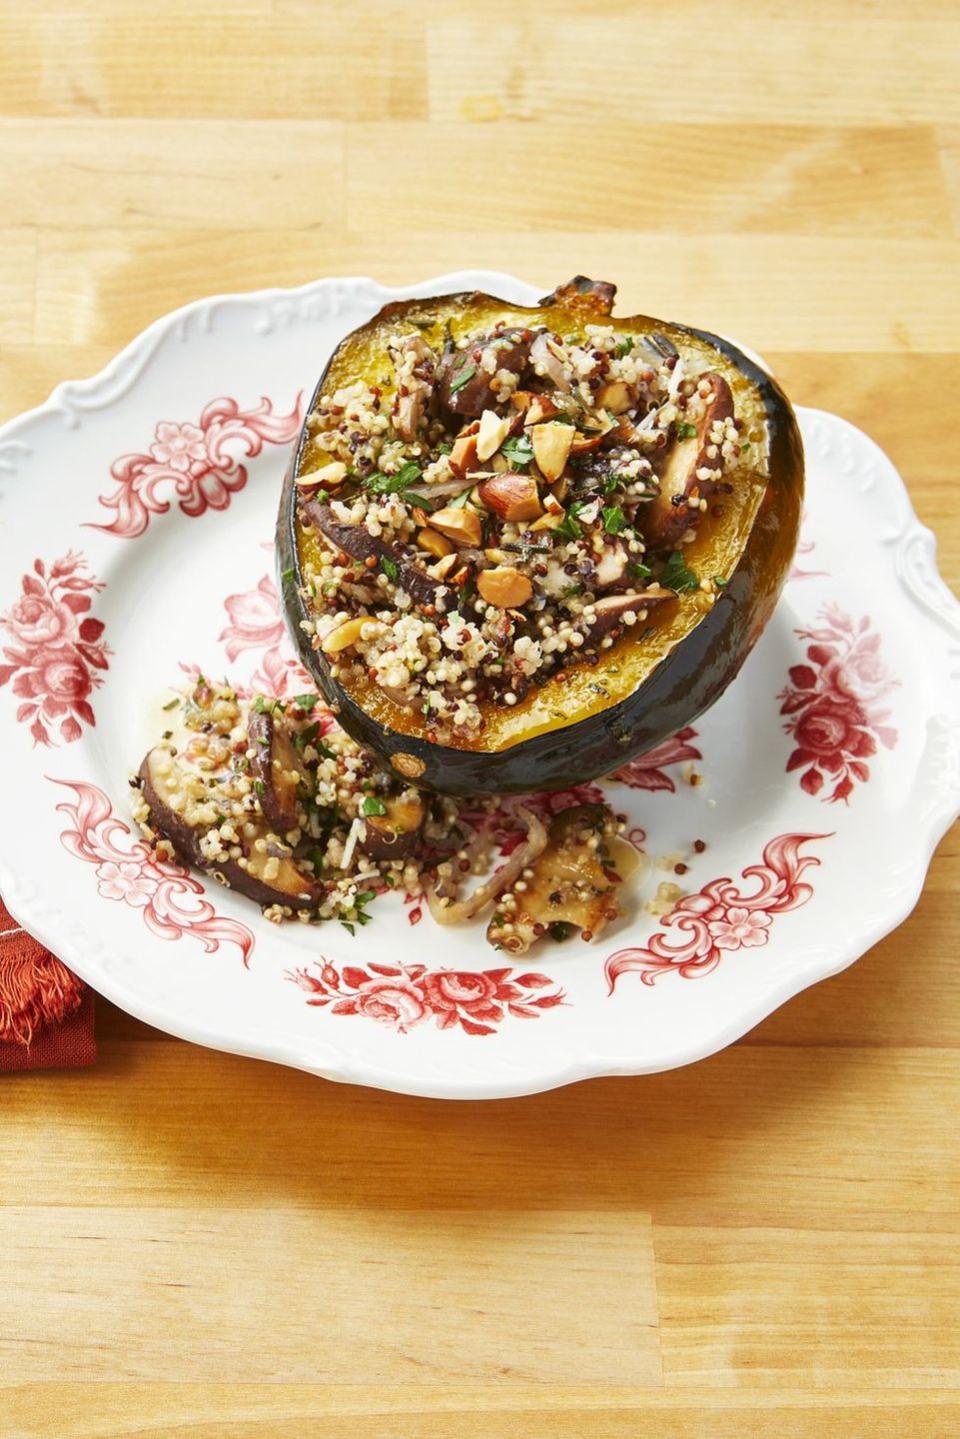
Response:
[276, 284, 803, 797]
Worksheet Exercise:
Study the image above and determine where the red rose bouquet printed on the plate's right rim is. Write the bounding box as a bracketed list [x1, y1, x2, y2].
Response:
[777, 604, 900, 803]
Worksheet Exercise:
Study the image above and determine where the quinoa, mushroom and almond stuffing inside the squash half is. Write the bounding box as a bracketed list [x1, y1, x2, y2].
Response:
[296, 302, 747, 745]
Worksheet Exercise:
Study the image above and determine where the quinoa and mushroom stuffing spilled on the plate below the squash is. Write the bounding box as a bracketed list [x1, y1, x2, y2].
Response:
[134, 678, 622, 954]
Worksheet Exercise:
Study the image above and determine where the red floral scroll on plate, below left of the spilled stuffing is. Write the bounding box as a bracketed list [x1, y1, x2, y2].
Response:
[53, 780, 255, 964]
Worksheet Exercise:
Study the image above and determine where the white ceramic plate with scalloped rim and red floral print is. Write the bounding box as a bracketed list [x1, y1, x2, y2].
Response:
[0, 272, 960, 1098]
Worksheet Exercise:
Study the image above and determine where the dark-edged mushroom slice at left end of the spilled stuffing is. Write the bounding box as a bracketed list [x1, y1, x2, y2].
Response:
[140, 747, 321, 909]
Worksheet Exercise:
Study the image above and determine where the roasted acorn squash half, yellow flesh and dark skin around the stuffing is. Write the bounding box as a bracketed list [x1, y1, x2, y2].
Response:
[276, 276, 803, 796]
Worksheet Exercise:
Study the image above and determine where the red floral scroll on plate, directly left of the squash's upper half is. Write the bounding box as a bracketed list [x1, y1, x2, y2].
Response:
[91, 394, 302, 540]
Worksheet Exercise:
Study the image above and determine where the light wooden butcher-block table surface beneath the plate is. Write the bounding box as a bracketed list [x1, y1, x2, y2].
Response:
[0, 0, 960, 1439]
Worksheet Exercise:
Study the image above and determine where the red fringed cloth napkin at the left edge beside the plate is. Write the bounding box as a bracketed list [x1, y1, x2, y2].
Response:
[0, 898, 96, 1073]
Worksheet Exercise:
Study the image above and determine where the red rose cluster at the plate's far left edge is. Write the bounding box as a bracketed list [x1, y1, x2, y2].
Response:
[0, 551, 111, 745]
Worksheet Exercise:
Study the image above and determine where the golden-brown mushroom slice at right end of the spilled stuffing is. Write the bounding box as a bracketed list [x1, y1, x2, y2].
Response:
[486, 804, 620, 954]
